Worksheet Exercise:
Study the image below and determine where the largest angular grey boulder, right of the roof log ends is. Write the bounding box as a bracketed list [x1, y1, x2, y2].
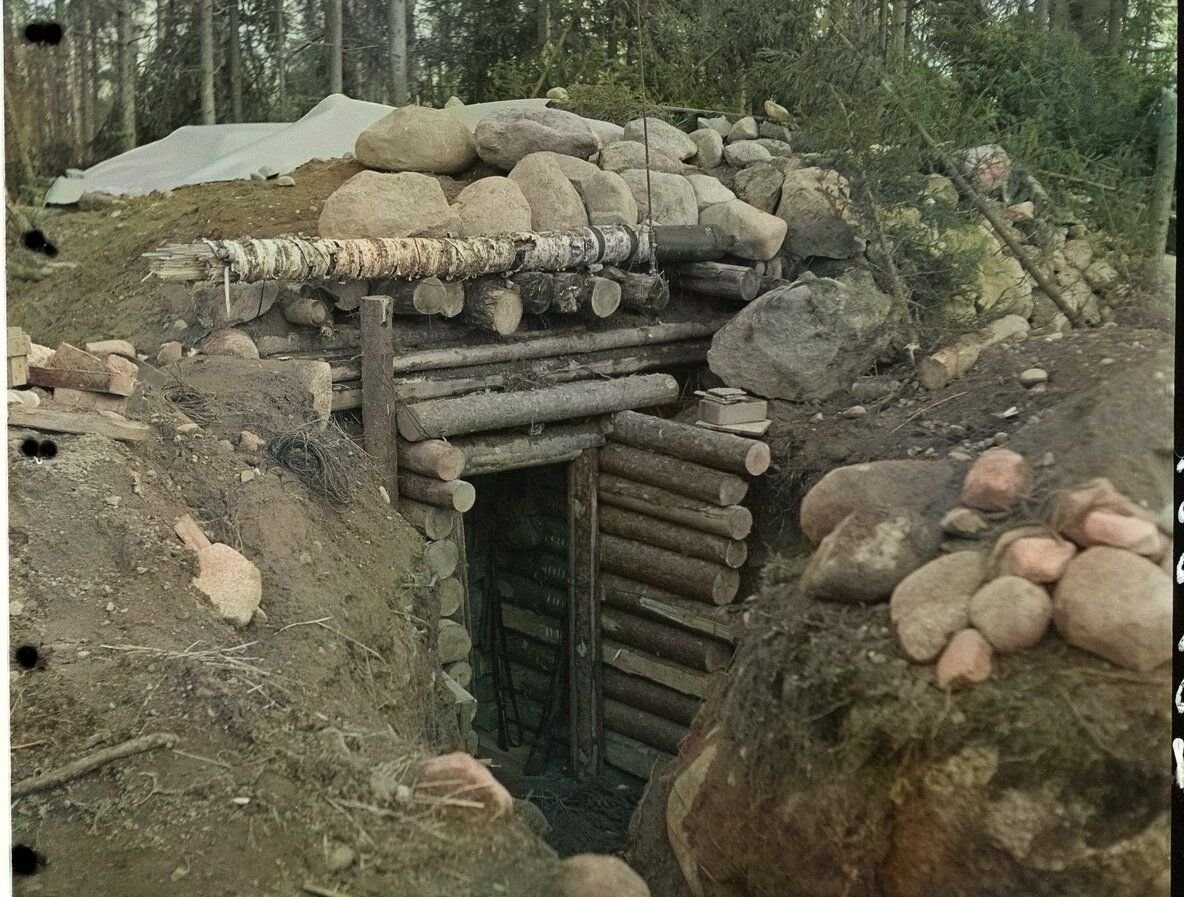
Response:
[707, 268, 900, 401]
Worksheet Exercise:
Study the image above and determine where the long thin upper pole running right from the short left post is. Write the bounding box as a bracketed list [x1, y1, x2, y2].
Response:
[388, 317, 731, 376]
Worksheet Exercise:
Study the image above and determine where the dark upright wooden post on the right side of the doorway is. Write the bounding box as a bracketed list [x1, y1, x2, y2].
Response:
[567, 449, 604, 781]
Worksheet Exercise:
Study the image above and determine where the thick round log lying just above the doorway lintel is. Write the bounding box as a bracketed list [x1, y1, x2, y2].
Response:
[398, 374, 681, 442]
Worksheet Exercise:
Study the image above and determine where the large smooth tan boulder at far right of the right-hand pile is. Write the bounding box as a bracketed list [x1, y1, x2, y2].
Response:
[1053, 547, 1172, 673]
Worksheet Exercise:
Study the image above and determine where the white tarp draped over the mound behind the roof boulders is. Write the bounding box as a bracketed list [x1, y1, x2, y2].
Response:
[45, 93, 548, 206]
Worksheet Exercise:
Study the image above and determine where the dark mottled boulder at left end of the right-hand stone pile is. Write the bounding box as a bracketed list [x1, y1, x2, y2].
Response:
[802, 508, 938, 604]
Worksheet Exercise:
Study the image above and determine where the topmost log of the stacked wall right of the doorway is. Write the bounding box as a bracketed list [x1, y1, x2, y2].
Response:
[612, 411, 771, 477]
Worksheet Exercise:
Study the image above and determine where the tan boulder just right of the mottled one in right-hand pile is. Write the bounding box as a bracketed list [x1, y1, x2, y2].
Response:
[888, 551, 986, 664]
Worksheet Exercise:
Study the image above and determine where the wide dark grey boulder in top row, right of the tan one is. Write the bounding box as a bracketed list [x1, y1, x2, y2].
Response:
[474, 109, 600, 170]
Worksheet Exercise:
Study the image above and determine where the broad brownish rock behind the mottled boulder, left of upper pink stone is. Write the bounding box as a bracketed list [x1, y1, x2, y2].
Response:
[799, 459, 966, 544]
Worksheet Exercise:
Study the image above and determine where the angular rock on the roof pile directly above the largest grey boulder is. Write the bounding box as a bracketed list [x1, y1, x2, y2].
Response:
[777, 168, 867, 258]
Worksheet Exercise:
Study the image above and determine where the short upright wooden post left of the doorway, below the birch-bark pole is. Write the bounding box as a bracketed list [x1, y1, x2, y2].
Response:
[361, 296, 399, 508]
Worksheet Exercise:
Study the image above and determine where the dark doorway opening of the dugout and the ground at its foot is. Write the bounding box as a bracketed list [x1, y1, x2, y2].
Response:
[464, 464, 645, 856]
